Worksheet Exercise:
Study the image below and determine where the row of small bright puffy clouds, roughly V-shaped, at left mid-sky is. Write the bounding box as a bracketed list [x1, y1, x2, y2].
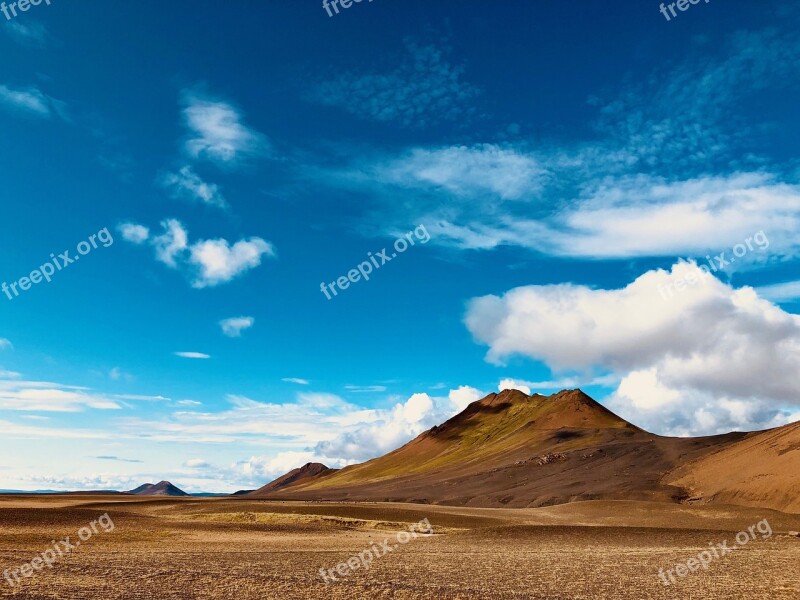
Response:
[123, 219, 275, 288]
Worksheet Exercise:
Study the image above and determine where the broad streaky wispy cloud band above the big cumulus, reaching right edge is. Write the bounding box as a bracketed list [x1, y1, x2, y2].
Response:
[311, 30, 800, 260]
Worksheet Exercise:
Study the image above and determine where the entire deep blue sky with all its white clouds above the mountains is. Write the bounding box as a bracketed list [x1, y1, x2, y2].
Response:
[0, 0, 800, 491]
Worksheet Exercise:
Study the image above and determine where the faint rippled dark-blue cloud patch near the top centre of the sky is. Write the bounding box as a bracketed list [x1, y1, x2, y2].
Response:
[311, 37, 480, 128]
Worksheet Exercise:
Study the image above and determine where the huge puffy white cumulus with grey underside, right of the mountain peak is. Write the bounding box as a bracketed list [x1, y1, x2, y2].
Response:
[466, 262, 800, 433]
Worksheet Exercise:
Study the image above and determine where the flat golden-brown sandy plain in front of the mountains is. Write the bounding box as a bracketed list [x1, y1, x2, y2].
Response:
[0, 496, 800, 600]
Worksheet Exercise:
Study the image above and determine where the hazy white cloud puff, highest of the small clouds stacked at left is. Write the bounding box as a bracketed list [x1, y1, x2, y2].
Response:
[183, 91, 268, 165]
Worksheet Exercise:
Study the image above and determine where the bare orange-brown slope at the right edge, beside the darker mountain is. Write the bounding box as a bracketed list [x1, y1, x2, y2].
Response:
[666, 422, 800, 513]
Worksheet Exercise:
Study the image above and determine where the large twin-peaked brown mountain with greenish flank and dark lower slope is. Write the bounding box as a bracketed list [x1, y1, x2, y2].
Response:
[247, 390, 797, 508]
